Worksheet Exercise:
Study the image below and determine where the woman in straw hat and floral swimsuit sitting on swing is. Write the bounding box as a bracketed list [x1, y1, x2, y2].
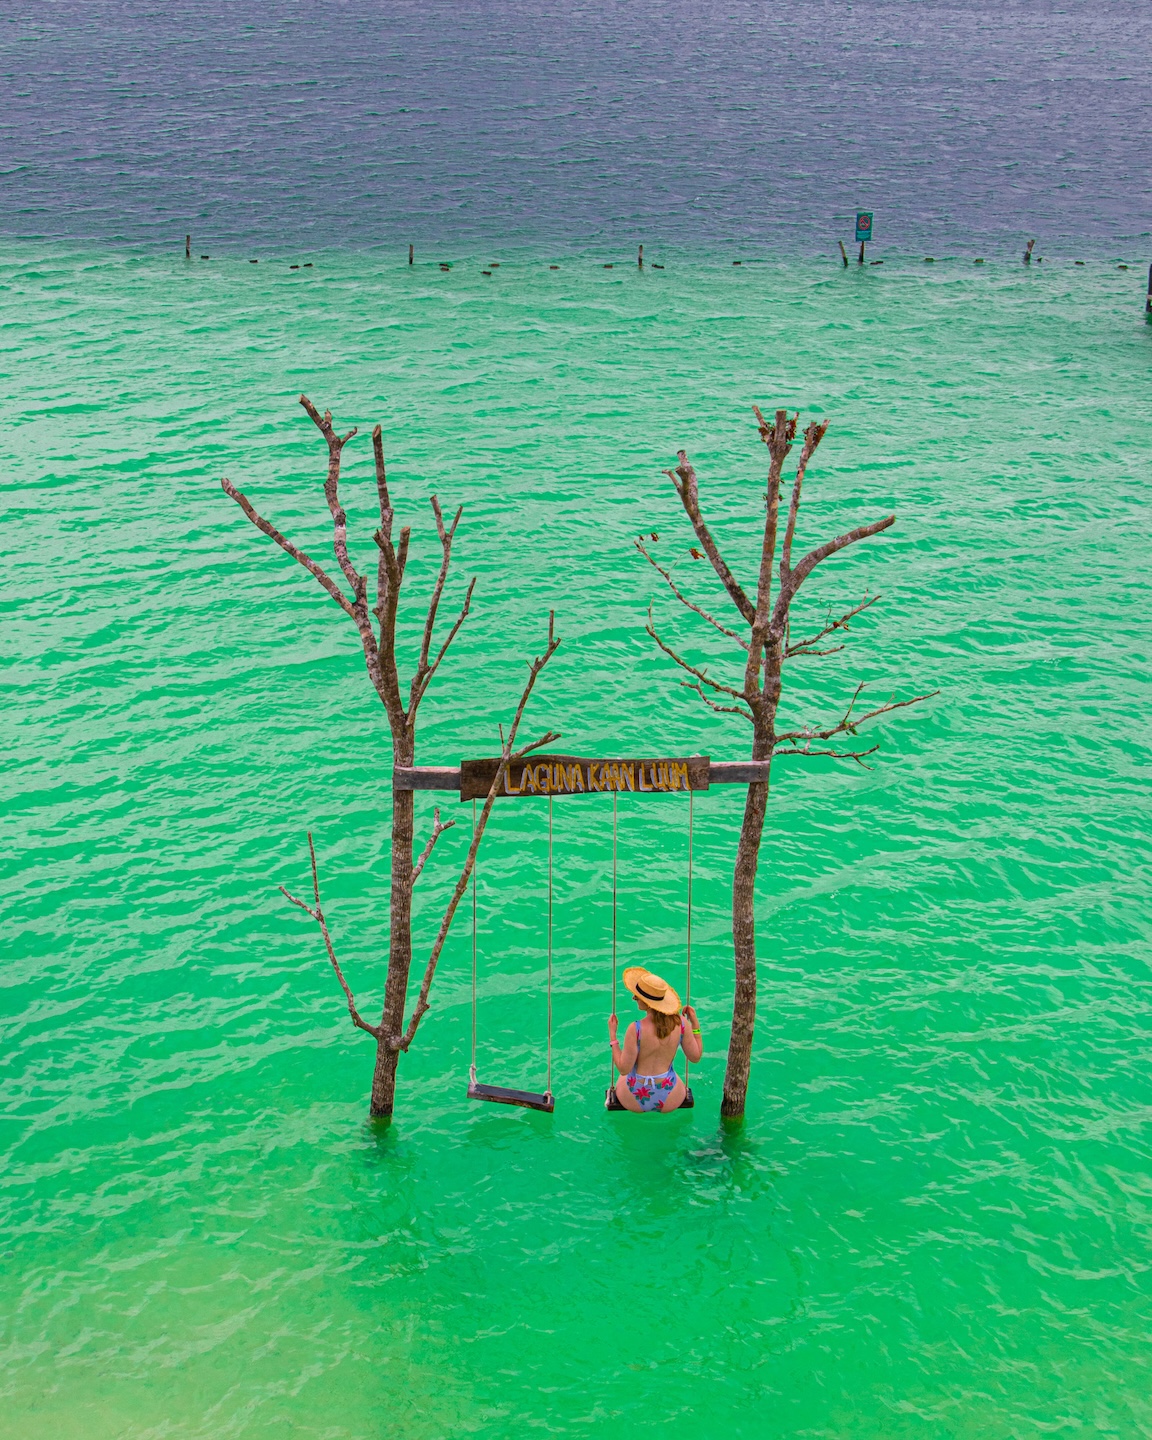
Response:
[608, 965, 704, 1113]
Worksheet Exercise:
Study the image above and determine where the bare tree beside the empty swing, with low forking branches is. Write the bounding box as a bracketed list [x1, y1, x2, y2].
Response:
[220, 395, 560, 1116]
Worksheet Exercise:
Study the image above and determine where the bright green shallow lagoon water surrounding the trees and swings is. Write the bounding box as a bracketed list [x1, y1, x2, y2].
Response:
[0, 243, 1152, 1440]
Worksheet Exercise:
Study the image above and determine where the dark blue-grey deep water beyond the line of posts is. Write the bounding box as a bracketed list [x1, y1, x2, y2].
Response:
[0, 0, 1152, 259]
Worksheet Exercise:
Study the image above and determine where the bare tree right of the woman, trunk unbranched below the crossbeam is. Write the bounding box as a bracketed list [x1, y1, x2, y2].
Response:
[636, 406, 939, 1117]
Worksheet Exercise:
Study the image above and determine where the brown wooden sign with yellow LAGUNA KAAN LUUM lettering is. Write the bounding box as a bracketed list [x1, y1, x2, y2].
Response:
[459, 755, 711, 801]
